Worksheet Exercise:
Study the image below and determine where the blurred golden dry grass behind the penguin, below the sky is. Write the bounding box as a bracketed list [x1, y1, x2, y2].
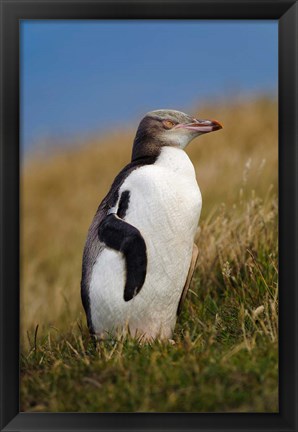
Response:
[21, 98, 278, 343]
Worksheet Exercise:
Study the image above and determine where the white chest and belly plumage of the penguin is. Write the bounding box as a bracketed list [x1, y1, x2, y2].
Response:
[90, 147, 202, 337]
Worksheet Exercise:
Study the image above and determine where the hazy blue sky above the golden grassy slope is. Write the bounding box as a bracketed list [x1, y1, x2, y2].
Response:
[21, 20, 278, 149]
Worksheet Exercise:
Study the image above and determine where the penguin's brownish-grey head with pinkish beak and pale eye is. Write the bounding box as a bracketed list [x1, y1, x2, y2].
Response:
[133, 109, 222, 159]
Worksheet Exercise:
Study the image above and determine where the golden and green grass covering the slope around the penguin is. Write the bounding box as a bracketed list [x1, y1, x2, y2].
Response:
[21, 98, 278, 412]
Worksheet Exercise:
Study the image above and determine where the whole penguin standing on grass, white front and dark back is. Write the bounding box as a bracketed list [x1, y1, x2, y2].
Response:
[81, 109, 222, 341]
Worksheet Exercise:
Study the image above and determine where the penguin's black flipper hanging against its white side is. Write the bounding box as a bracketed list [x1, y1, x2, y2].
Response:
[98, 213, 147, 301]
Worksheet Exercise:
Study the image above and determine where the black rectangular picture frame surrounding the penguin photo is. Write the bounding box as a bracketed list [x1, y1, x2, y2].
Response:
[0, 0, 298, 432]
